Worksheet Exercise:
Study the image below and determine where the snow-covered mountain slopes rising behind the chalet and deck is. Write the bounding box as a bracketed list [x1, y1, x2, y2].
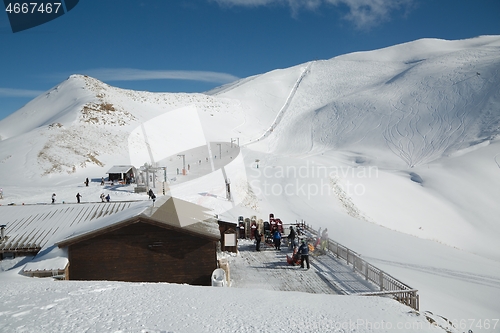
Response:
[0, 36, 500, 326]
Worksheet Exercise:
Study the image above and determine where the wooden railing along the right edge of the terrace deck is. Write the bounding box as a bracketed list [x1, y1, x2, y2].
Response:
[301, 223, 419, 311]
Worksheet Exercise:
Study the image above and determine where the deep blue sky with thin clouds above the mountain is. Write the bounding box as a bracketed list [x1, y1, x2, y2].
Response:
[0, 0, 500, 119]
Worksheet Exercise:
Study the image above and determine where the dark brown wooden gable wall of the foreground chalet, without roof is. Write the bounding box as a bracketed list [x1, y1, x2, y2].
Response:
[68, 222, 217, 285]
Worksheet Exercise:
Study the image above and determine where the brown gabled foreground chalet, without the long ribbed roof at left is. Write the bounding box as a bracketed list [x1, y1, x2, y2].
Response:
[57, 198, 220, 285]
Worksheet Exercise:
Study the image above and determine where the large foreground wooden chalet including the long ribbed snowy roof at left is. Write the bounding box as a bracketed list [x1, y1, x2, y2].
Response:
[0, 197, 221, 285]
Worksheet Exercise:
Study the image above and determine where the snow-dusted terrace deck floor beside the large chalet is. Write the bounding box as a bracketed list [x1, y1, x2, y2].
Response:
[229, 240, 379, 295]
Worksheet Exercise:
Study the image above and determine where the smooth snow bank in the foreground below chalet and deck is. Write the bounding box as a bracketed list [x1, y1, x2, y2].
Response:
[0, 280, 452, 333]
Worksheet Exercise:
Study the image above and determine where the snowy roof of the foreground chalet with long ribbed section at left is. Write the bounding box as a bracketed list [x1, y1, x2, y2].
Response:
[0, 197, 220, 271]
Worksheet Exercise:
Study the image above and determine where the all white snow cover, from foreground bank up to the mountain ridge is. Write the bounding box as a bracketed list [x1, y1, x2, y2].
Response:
[0, 36, 500, 332]
